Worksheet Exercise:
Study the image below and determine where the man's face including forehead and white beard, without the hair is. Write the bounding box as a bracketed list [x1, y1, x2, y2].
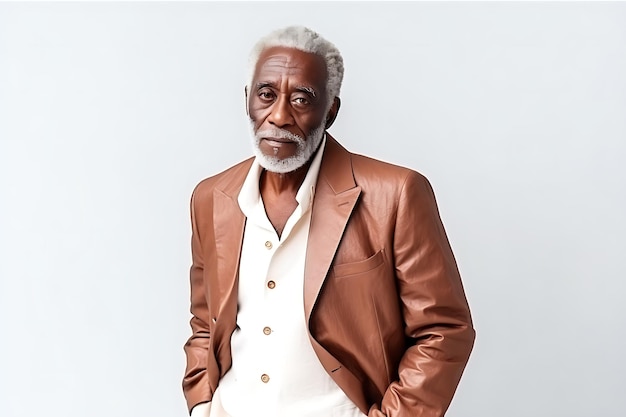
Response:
[247, 47, 328, 173]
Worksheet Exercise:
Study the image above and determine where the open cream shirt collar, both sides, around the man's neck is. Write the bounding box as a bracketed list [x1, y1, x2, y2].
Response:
[237, 133, 326, 217]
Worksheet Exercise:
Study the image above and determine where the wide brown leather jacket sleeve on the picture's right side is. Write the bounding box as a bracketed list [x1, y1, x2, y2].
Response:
[369, 171, 475, 417]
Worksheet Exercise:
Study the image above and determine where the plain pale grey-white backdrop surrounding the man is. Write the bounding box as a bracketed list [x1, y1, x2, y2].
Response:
[0, 2, 626, 417]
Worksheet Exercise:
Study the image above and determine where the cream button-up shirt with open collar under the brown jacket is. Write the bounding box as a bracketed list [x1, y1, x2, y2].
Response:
[191, 138, 363, 417]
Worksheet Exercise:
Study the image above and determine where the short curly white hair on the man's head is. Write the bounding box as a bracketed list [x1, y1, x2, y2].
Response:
[247, 26, 343, 108]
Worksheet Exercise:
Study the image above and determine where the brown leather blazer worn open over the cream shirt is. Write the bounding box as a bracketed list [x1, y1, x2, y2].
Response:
[183, 136, 474, 417]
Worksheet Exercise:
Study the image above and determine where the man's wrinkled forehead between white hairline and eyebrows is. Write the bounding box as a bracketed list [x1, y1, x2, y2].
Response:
[254, 46, 328, 89]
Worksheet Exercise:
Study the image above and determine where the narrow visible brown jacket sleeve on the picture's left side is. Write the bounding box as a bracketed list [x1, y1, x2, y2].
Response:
[183, 188, 212, 411]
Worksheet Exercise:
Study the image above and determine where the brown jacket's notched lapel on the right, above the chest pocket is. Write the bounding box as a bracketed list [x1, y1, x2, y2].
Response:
[304, 135, 361, 326]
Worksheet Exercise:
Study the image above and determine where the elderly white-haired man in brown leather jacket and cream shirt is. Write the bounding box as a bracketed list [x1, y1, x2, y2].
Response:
[183, 27, 474, 417]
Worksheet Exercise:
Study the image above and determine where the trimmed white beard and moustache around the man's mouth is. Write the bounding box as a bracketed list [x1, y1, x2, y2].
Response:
[250, 121, 326, 174]
